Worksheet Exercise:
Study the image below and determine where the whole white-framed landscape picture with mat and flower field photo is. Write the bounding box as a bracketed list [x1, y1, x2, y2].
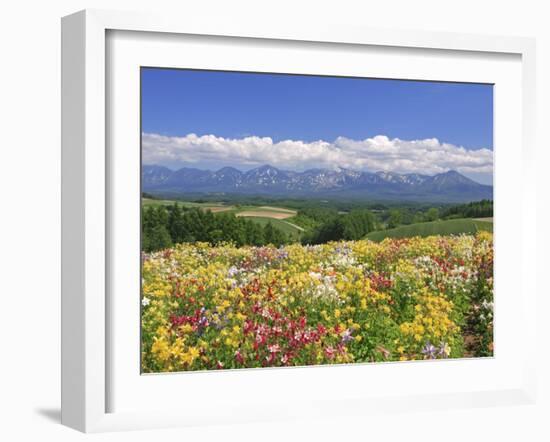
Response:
[62, 11, 537, 432]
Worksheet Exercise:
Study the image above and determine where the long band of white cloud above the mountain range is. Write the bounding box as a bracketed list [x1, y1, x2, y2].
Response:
[142, 133, 493, 177]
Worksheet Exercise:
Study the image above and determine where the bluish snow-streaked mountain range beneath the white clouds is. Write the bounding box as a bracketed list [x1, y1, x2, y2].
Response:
[141, 165, 493, 202]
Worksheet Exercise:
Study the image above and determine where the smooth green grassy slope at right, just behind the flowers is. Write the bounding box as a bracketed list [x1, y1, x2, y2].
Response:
[366, 218, 493, 241]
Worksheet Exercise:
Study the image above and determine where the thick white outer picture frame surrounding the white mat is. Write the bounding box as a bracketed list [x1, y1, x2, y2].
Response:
[62, 10, 537, 432]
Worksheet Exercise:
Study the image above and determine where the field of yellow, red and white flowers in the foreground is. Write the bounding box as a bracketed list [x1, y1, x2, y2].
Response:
[141, 232, 493, 373]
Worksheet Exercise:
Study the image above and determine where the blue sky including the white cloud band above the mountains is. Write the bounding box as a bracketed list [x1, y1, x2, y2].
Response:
[141, 68, 493, 182]
